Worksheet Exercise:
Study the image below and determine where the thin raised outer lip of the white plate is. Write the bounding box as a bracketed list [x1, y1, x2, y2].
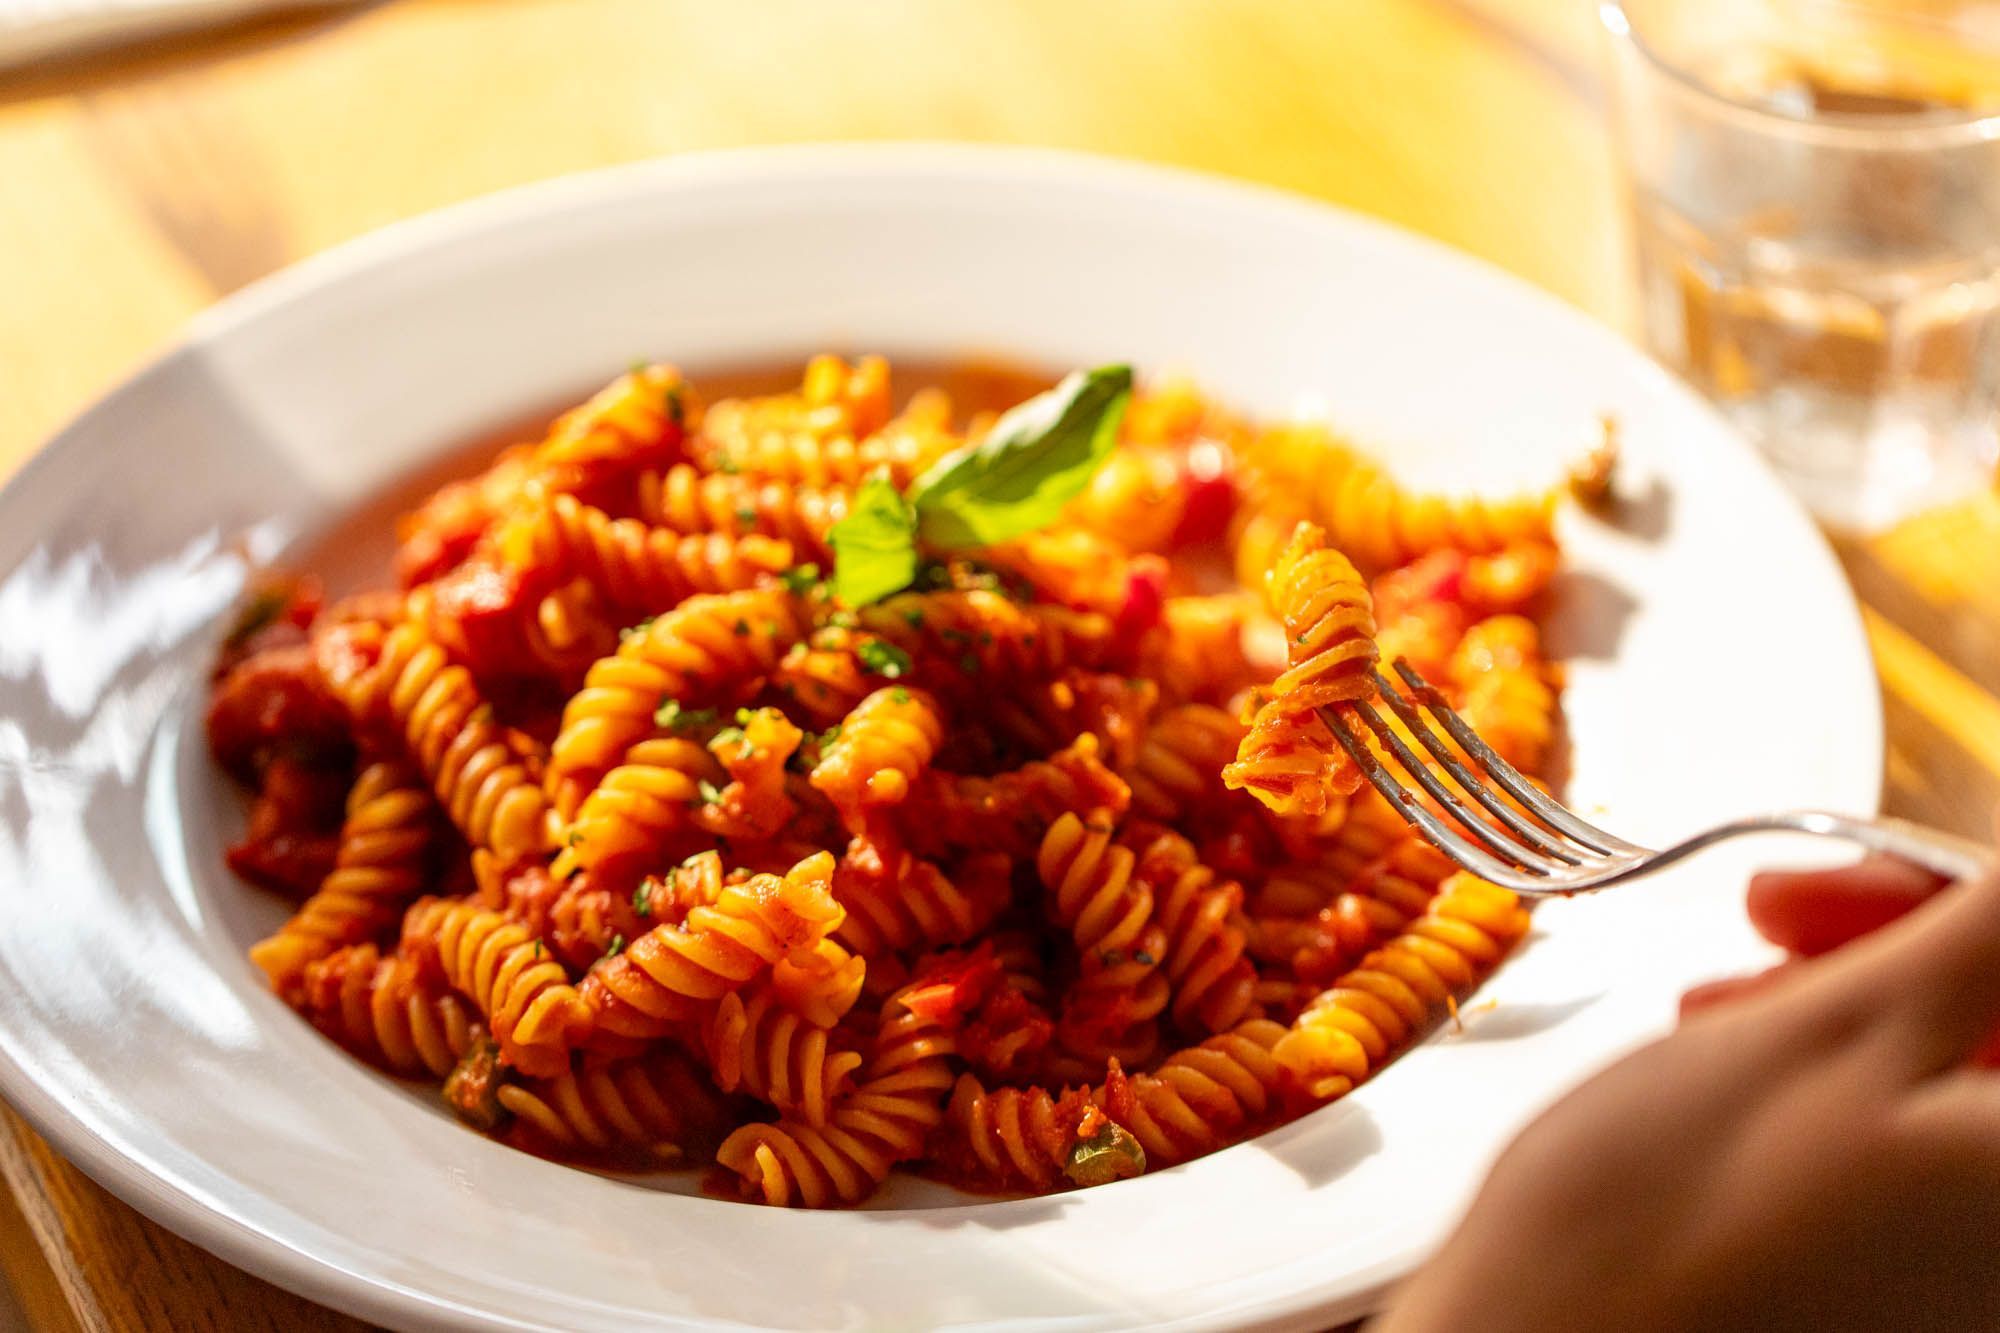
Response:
[0, 140, 1886, 1329]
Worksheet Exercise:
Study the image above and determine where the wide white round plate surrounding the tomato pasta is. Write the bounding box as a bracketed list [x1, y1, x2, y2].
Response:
[0, 148, 1880, 1329]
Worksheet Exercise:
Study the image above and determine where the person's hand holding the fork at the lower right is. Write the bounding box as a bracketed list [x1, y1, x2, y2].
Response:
[1376, 863, 2000, 1333]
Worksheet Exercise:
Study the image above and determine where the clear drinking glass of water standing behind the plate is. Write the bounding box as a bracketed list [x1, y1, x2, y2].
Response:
[1602, 0, 2000, 532]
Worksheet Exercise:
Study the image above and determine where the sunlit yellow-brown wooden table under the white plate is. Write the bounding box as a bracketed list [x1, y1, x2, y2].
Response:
[0, 0, 2000, 1329]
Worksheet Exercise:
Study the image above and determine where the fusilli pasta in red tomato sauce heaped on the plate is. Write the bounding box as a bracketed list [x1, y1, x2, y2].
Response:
[208, 356, 1562, 1207]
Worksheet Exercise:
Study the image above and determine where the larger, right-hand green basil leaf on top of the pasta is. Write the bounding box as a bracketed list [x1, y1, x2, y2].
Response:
[910, 366, 1132, 550]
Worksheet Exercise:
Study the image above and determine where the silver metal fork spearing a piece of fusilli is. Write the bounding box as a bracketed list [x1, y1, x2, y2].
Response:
[1320, 660, 1996, 897]
